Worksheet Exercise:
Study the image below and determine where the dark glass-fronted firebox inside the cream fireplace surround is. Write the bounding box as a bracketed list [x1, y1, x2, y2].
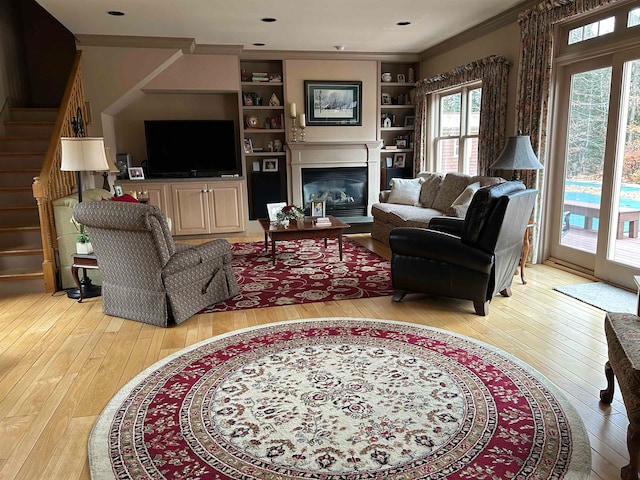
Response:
[302, 167, 367, 217]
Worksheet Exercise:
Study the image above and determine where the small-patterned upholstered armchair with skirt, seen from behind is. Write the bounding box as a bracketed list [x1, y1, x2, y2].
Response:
[73, 201, 239, 327]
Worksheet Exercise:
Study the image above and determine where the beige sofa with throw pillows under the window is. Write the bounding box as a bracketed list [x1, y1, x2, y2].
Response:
[371, 172, 505, 245]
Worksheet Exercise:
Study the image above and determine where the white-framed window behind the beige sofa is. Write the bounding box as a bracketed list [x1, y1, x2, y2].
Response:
[431, 83, 482, 175]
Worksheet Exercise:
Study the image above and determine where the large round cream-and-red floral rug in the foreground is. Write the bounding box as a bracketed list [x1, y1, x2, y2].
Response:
[89, 318, 591, 480]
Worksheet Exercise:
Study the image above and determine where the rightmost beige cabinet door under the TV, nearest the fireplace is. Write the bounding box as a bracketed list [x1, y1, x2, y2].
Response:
[209, 182, 244, 233]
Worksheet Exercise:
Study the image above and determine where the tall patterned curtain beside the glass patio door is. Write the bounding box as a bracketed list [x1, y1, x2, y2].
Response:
[520, 0, 616, 262]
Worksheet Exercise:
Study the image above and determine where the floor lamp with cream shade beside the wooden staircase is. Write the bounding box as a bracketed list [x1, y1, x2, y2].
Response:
[60, 137, 109, 298]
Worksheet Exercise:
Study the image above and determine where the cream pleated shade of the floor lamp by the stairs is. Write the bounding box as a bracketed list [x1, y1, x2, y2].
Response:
[60, 137, 110, 172]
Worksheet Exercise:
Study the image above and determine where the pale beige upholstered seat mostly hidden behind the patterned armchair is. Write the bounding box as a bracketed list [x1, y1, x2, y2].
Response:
[52, 188, 112, 289]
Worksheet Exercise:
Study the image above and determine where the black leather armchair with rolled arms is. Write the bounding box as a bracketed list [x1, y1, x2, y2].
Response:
[389, 181, 537, 316]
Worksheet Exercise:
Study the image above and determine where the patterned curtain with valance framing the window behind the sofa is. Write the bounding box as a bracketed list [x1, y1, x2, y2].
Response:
[413, 55, 511, 176]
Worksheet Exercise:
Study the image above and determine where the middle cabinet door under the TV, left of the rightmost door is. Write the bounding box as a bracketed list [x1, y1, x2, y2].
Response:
[171, 182, 211, 235]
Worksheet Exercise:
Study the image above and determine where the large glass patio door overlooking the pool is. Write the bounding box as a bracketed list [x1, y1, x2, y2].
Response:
[548, 52, 640, 288]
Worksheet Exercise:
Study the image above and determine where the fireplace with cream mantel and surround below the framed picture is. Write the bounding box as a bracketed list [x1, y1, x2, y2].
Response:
[287, 140, 382, 217]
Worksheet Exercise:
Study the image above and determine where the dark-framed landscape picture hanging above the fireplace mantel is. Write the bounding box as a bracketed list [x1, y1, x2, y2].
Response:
[304, 80, 362, 127]
